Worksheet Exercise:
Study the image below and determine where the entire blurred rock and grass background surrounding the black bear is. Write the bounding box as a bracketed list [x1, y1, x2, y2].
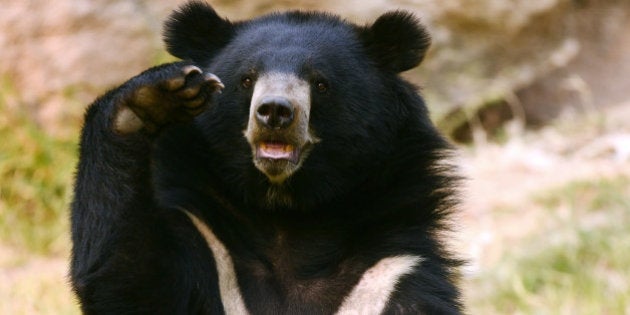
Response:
[0, 0, 630, 314]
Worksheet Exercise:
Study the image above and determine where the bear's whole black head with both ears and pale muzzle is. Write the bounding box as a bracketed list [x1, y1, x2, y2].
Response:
[165, 1, 430, 209]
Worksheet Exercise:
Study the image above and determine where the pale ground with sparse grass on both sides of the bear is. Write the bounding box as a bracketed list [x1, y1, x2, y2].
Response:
[0, 101, 630, 314]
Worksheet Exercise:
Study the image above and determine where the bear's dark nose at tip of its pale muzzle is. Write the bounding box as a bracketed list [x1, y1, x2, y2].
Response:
[256, 96, 293, 129]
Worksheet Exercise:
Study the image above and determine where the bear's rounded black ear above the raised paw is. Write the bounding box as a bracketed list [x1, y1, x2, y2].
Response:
[164, 1, 234, 62]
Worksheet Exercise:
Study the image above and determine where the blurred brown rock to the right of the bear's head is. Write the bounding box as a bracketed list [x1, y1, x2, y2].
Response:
[428, 0, 630, 138]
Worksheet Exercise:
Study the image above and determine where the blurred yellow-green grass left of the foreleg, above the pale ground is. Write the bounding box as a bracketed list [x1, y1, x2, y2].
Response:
[0, 86, 78, 254]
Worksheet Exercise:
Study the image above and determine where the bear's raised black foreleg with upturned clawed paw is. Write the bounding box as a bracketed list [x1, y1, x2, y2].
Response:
[71, 62, 223, 313]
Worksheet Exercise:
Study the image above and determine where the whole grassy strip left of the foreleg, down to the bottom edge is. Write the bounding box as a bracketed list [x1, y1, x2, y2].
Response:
[0, 78, 79, 314]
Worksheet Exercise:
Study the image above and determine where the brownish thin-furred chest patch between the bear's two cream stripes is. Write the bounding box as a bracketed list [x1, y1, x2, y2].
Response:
[234, 245, 366, 314]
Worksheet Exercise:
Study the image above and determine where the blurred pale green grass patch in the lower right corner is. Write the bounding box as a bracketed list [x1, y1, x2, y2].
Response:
[470, 177, 630, 314]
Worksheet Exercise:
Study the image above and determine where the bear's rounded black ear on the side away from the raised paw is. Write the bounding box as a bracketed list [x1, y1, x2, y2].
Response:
[359, 11, 431, 73]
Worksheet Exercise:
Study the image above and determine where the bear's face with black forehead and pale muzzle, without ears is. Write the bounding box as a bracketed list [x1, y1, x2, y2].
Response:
[220, 17, 371, 184]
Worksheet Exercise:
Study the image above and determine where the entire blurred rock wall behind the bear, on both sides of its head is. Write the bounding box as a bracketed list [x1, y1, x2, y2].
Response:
[0, 0, 630, 138]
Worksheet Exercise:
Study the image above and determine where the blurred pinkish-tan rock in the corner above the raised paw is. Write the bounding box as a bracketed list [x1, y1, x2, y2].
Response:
[0, 0, 185, 136]
